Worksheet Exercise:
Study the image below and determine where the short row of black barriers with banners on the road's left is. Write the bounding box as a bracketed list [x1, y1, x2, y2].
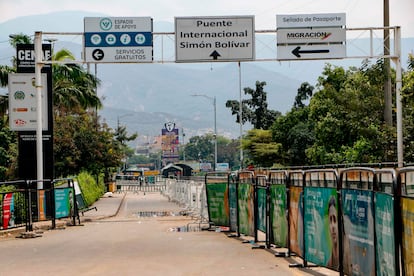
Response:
[0, 179, 83, 231]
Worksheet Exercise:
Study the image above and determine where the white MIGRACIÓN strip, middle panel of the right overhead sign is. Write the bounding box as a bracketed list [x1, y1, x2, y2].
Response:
[277, 28, 346, 44]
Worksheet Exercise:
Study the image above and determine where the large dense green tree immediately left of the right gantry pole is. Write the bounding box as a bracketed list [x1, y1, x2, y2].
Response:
[306, 61, 395, 164]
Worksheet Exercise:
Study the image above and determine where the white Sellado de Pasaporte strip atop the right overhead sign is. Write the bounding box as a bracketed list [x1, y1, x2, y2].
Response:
[276, 13, 346, 28]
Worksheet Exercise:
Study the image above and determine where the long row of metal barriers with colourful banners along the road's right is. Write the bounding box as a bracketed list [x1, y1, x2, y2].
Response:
[205, 167, 414, 275]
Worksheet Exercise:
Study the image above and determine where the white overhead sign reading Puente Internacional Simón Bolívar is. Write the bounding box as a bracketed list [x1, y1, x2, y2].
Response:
[175, 16, 255, 62]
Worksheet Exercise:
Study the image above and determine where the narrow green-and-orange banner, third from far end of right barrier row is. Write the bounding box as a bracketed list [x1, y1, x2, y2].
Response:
[238, 183, 254, 236]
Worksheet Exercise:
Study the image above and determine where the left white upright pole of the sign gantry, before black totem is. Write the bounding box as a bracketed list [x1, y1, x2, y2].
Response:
[34, 32, 43, 190]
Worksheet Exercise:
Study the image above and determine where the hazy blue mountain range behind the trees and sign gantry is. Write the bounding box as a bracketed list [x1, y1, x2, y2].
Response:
[0, 11, 414, 141]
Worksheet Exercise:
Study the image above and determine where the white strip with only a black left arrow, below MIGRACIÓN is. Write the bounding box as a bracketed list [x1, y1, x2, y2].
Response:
[277, 44, 346, 60]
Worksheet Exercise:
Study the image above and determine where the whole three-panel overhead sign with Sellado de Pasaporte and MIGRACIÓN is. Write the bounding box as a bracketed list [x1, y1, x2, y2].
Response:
[276, 13, 346, 60]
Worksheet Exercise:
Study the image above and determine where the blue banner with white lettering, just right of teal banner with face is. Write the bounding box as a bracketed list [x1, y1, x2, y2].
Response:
[341, 189, 375, 275]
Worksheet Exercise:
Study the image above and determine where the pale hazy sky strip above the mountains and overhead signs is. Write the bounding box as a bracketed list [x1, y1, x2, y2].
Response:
[0, 0, 414, 37]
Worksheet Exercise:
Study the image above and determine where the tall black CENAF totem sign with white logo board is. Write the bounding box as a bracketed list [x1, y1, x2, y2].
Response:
[14, 44, 54, 182]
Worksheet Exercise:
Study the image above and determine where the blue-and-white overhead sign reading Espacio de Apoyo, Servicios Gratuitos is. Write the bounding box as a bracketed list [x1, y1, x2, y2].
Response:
[84, 17, 153, 63]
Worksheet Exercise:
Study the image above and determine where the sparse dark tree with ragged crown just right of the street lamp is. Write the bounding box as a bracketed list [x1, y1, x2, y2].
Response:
[226, 81, 281, 129]
